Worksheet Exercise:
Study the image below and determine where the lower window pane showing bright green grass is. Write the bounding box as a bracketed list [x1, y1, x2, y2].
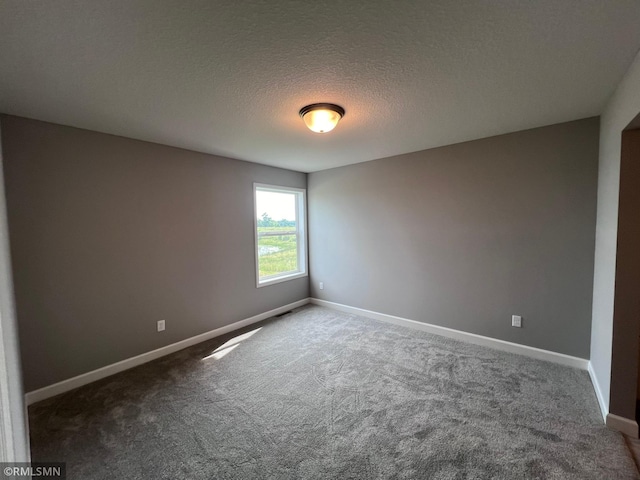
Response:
[258, 232, 298, 278]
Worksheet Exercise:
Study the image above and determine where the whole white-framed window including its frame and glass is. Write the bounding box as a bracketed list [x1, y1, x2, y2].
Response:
[253, 183, 307, 287]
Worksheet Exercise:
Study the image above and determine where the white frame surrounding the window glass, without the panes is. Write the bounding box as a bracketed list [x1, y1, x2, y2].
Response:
[253, 183, 309, 288]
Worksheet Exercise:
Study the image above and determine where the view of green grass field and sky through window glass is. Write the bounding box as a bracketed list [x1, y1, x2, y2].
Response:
[256, 190, 300, 280]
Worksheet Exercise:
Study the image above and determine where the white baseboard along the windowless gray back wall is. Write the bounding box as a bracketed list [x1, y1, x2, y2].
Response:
[311, 298, 589, 370]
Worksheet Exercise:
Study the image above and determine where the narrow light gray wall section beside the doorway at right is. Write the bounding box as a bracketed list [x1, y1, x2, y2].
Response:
[591, 47, 640, 413]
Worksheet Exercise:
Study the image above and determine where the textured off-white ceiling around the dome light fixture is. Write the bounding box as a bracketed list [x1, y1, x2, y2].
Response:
[0, 0, 640, 172]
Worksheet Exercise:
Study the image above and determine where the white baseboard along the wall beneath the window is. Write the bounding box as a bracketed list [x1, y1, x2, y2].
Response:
[25, 298, 310, 405]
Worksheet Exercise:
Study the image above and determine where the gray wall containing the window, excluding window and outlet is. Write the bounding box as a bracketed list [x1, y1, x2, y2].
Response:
[1, 116, 309, 391]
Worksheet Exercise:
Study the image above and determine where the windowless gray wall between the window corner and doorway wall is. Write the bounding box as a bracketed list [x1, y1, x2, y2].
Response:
[308, 118, 599, 358]
